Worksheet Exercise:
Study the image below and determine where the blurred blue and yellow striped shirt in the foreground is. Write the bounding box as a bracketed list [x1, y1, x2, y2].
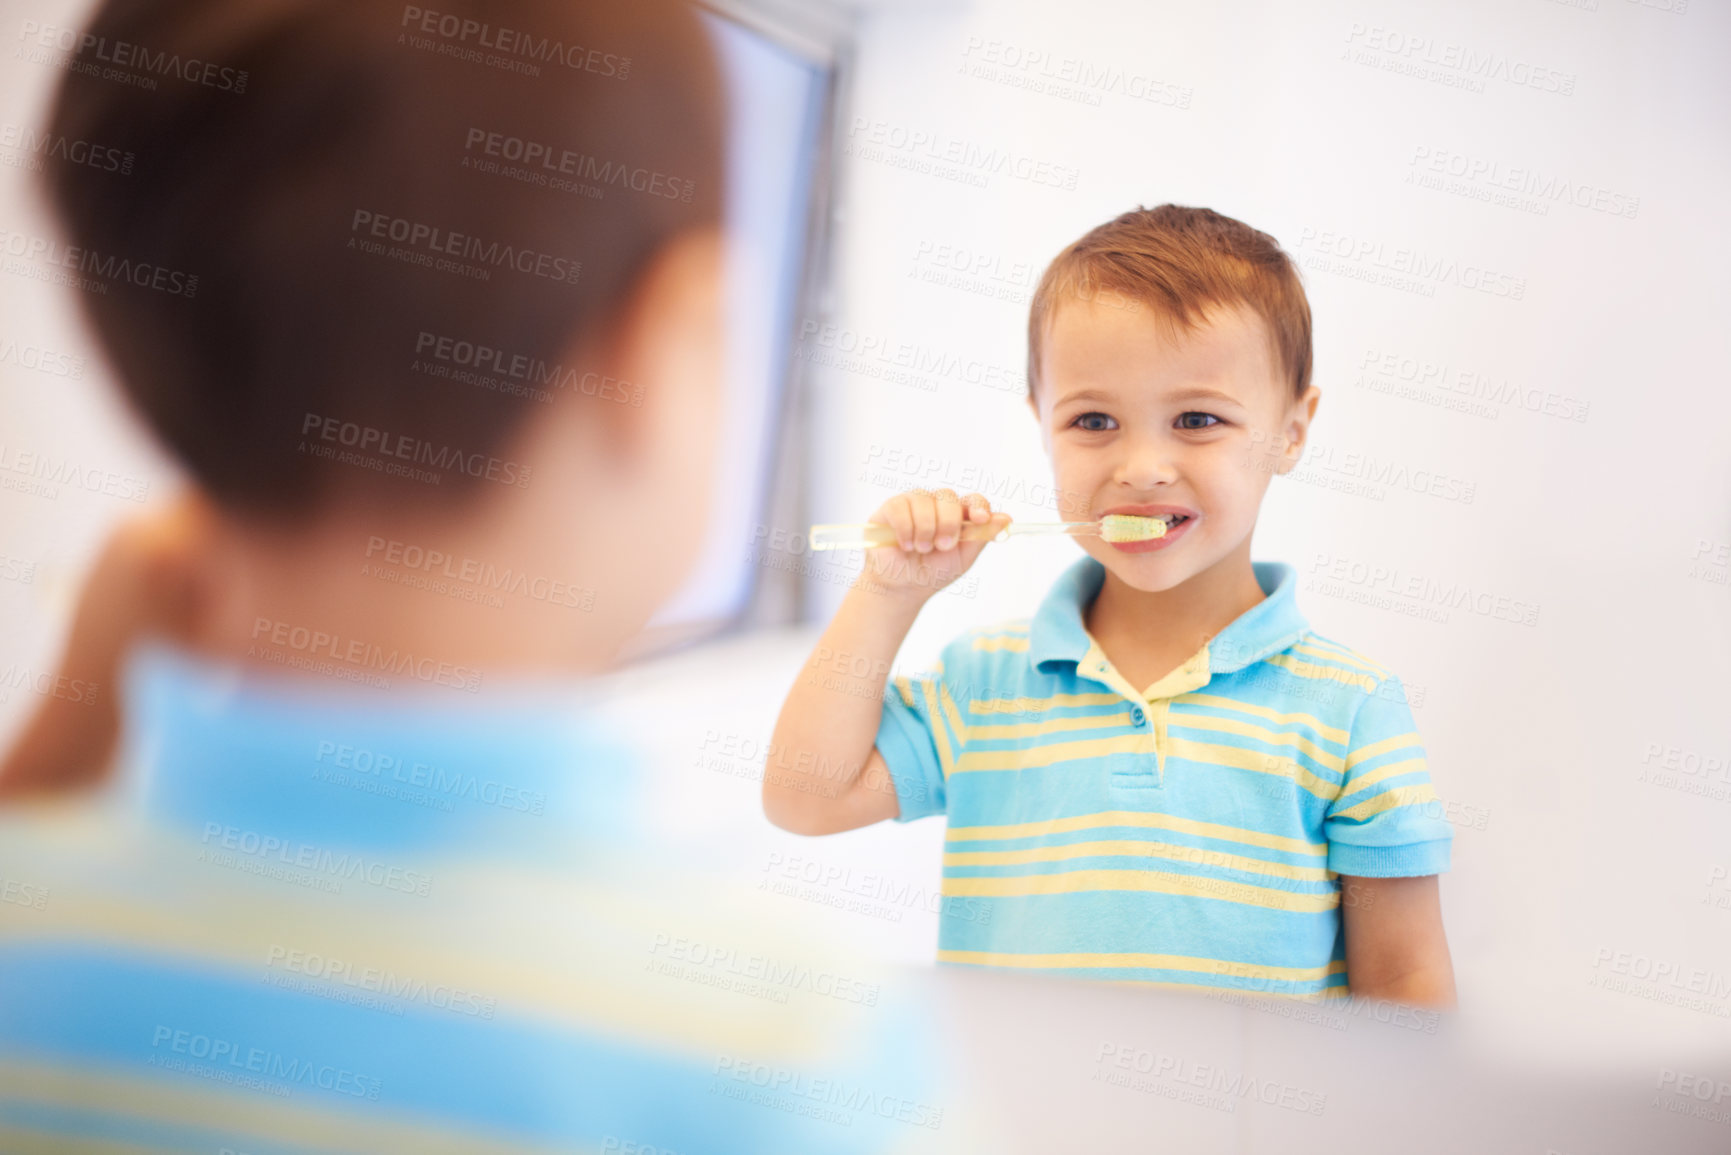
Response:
[0, 648, 961, 1155]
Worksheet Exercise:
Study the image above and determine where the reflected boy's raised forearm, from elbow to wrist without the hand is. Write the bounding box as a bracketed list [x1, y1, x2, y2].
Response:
[763, 575, 924, 833]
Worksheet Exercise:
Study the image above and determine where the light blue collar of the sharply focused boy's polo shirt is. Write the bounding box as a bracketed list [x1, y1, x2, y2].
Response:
[1028, 556, 1310, 674]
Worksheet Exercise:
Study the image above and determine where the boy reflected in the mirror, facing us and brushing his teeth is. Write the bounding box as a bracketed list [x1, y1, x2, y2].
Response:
[763, 204, 1454, 1006]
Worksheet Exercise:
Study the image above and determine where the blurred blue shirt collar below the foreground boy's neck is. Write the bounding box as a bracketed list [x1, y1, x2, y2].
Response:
[125, 642, 635, 859]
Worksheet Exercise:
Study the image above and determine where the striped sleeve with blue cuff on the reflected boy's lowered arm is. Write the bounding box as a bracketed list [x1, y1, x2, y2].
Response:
[1322, 675, 1454, 878]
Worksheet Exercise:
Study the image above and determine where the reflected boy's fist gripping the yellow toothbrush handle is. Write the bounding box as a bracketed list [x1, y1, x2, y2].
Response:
[866, 490, 1011, 601]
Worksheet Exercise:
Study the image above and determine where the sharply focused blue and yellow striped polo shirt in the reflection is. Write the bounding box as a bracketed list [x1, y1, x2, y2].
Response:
[878, 558, 1452, 997]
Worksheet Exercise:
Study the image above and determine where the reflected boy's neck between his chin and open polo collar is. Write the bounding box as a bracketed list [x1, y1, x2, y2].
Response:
[1084, 539, 1267, 671]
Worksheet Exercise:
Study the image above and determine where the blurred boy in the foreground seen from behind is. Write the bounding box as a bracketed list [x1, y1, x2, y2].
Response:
[0, 0, 950, 1155]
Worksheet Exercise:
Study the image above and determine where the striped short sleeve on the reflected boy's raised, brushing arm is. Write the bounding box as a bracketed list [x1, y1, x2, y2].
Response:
[878, 639, 966, 823]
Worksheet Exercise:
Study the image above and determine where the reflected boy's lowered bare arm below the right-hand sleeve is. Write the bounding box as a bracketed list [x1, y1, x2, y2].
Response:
[1340, 874, 1454, 1010]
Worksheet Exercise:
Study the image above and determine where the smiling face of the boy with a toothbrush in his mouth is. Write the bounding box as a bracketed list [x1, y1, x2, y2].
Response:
[1030, 294, 1319, 592]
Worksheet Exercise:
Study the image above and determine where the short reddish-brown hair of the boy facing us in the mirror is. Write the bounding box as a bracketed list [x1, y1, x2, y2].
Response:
[1028, 204, 1310, 400]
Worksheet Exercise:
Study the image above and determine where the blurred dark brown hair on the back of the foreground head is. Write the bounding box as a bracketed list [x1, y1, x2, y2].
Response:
[47, 0, 724, 518]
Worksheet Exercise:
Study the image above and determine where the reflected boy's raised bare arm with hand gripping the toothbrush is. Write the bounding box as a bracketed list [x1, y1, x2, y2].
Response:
[763, 490, 1009, 835]
